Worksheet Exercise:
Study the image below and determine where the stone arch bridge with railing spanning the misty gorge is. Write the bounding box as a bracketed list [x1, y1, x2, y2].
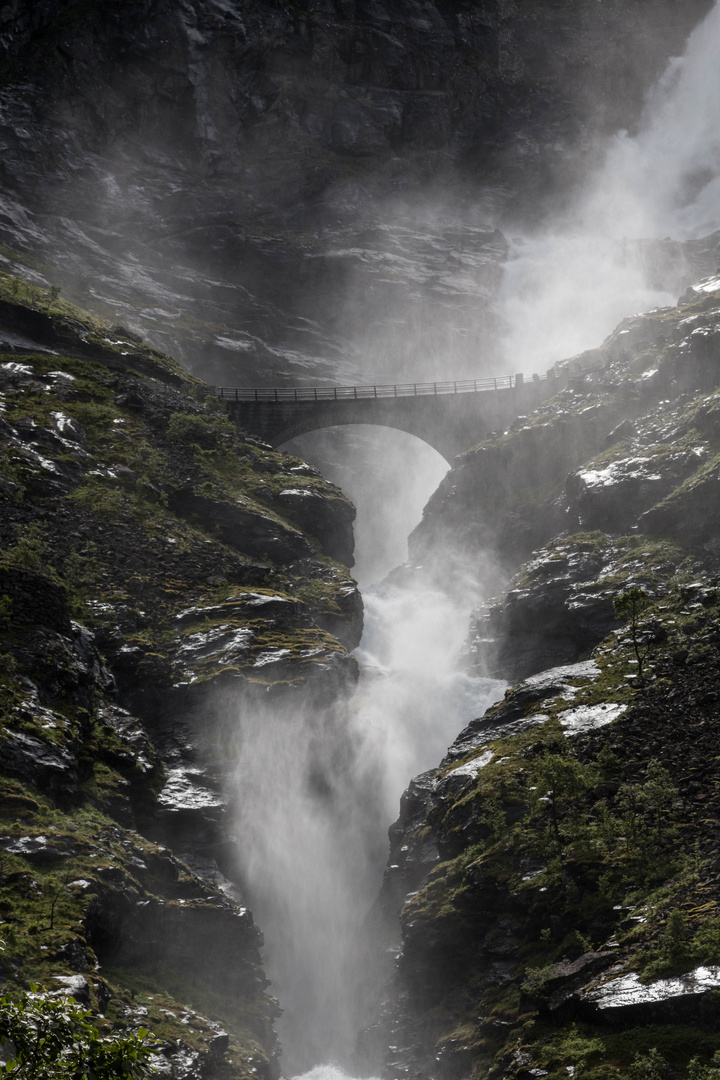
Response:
[218, 370, 565, 462]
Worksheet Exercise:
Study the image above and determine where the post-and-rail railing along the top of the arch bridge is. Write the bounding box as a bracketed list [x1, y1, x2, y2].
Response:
[213, 375, 535, 402]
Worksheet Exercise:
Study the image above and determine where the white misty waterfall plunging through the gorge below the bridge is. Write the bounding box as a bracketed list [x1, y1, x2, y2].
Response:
[237, 584, 504, 1070]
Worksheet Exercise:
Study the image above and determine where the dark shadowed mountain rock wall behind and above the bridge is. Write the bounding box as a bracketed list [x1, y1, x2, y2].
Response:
[0, 0, 710, 383]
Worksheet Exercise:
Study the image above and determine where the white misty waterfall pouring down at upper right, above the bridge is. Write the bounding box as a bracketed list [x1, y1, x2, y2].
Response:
[499, 4, 720, 372]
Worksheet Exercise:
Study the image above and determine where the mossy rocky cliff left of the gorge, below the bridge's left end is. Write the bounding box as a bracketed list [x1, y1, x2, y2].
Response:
[0, 276, 362, 1080]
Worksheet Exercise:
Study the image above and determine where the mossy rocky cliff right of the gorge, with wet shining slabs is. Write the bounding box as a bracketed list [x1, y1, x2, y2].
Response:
[376, 275, 720, 1080]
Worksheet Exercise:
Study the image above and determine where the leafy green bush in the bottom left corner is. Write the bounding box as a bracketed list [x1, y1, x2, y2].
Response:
[0, 987, 157, 1080]
